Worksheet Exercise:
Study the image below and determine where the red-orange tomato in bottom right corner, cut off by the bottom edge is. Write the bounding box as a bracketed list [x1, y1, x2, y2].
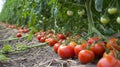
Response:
[97, 55, 118, 67]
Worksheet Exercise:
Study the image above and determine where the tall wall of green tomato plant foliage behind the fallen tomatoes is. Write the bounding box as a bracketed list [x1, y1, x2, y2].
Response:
[0, 0, 120, 37]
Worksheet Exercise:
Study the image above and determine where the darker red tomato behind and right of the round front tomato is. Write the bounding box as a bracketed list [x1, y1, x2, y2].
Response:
[91, 42, 105, 57]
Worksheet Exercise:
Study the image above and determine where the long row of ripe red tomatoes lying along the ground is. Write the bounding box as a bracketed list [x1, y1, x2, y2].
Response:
[6, 22, 120, 67]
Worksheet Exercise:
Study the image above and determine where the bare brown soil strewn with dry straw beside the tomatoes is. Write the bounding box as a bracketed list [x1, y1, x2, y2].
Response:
[0, 24, 96, 67]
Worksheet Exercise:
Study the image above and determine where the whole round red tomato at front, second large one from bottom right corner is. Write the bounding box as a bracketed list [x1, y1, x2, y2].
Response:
[78, 49, 95, 64]
